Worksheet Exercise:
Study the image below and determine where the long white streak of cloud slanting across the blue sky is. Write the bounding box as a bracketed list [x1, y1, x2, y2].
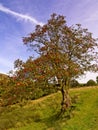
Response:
[0, 4, 44, 26]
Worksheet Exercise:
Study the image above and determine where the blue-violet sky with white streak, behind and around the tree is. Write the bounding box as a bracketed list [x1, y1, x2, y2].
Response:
[0, 0, 98, 82]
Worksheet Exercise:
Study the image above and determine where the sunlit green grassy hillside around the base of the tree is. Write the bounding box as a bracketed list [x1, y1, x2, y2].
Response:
[0, 87, 98, 130]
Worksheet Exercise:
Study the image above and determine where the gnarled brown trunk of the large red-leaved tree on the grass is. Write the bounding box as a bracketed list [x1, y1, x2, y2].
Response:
[61, 86, 71, 113]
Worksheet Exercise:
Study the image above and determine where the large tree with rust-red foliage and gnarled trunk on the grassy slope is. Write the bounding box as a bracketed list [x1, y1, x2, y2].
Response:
[23, 14, 98, 112]
